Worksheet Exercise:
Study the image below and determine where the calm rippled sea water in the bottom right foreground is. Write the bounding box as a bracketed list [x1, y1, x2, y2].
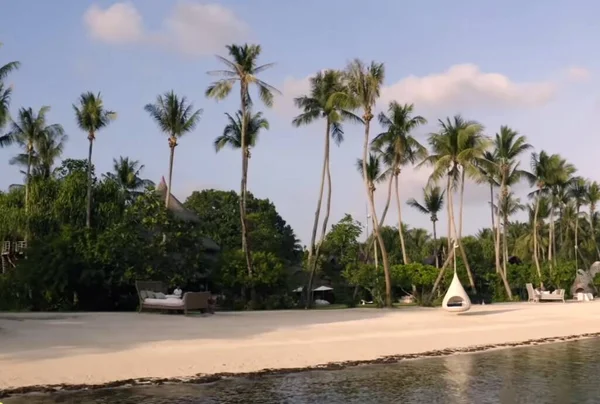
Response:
[3, 339, 600, 404]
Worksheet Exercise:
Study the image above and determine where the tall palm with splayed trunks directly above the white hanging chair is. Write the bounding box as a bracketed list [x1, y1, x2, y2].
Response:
[419, 115, 487, 291]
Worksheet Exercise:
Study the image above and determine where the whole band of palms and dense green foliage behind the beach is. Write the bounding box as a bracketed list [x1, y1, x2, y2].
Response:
[0, 41, 600, 310]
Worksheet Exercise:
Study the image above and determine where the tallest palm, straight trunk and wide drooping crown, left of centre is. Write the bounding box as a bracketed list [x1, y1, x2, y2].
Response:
[205, 44, 279, 290]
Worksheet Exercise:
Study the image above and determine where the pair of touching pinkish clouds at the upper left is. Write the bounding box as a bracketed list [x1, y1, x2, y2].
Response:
[84, 1, 249, 56]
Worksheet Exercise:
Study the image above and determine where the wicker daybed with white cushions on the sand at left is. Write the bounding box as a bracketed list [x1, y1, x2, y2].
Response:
[135, 281, 212, 315]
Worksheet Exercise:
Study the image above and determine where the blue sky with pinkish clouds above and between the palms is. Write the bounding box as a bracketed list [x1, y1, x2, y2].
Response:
[0, 0, 600, 243]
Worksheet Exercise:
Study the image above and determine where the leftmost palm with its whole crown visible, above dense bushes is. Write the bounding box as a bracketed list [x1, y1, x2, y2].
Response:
[5, 106, 64, 212]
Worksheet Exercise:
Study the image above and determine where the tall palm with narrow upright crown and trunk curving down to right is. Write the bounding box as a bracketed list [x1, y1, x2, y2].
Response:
[346, 59, 392, 307]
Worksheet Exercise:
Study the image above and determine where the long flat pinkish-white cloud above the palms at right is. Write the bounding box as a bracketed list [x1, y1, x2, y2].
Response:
[382, 64, 556, 108]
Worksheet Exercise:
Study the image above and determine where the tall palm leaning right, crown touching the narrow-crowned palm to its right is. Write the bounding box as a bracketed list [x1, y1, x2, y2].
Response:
[292, 70, 361, 306]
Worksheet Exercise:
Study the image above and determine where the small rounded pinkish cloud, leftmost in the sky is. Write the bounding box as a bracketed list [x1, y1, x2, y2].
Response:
[83, 2, 144, 43]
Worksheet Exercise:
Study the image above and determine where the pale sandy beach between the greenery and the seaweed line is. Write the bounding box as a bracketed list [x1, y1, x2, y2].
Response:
[0, 302, 600, 389]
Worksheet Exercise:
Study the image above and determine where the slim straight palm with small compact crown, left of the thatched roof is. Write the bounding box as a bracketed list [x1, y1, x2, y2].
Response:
[73, 92, 117, 229]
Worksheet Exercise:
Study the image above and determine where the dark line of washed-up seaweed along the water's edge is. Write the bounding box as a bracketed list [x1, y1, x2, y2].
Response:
[0, 332, 600, 398]
